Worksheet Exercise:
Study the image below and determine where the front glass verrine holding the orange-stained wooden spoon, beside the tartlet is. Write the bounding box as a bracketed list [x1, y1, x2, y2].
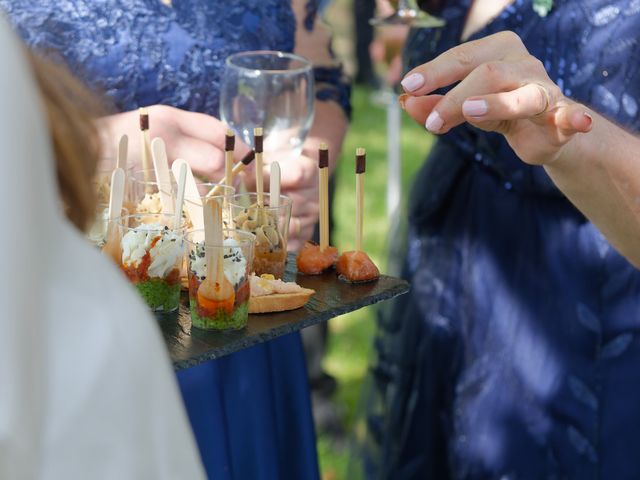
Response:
[186, 229, 255, 330]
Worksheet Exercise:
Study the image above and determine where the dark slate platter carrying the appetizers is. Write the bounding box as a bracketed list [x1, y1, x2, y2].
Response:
[157, 255, 409, 370]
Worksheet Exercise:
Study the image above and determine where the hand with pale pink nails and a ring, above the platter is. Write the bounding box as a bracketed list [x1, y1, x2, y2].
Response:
[400, 32, 593, 165]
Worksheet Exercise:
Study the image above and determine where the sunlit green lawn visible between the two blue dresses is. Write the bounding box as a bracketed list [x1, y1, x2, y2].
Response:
[318, 87, 432, 480]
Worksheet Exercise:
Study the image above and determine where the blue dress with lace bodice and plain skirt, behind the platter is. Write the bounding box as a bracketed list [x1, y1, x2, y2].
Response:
[0, 0, 348, 480]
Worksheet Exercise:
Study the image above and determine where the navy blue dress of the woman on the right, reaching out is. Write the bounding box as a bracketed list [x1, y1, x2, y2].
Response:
[365, 0, 640, 480]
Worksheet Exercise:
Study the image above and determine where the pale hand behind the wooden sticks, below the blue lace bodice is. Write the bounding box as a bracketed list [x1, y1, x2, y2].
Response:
[99, 105, 249, 181]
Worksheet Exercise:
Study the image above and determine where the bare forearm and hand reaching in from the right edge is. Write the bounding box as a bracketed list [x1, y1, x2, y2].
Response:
[400, 32, 640, 265]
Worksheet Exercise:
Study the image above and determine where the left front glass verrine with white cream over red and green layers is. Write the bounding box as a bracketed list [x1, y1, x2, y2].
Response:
[117, 213, 186, 312]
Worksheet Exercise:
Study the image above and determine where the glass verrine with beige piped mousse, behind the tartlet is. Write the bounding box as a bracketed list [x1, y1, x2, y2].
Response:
[230, 193, 292, 278]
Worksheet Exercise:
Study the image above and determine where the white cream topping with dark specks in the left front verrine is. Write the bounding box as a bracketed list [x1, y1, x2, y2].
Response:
[121, 223, 184, 278]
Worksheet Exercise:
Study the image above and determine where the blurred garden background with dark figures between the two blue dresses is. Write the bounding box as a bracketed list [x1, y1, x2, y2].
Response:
[314, 0, 432, 480]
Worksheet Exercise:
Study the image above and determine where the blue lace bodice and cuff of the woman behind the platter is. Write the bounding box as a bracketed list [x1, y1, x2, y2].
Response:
[0, 0, 350, 116]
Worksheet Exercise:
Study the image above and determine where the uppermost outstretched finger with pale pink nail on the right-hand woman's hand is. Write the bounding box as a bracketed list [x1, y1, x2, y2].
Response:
[400, 32, 528, 96]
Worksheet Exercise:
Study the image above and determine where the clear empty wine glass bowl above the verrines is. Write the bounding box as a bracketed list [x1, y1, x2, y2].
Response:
[220, 50, 315, 161]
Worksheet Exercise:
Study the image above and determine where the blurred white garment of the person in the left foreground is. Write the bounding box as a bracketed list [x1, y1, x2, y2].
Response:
[0, 19, 204, 480]
